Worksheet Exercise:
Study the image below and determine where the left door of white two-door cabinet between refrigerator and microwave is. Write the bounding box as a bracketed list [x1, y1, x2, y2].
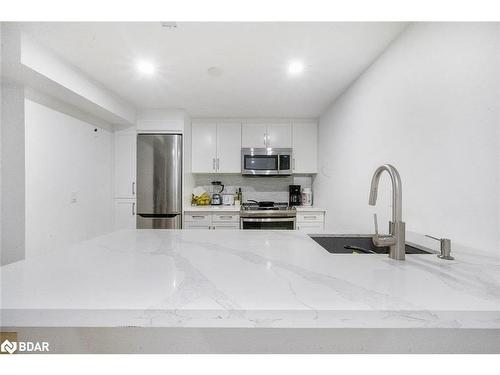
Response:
[191, 123, 217, 173]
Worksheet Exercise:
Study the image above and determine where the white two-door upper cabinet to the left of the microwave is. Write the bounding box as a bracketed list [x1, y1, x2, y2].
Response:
[191, 123, 241, 173]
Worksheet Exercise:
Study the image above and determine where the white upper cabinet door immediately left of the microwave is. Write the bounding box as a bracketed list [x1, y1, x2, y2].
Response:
[217, 123, 241, 173]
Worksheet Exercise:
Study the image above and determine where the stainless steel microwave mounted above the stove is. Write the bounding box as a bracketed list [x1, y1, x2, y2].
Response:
[241, 148, 292, 176]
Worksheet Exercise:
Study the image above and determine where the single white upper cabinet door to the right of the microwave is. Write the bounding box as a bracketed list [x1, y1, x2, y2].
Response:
[292, 123, 318, 173]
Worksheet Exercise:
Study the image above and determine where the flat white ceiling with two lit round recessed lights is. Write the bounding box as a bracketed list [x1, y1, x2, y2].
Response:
[18, 22, 406, 117]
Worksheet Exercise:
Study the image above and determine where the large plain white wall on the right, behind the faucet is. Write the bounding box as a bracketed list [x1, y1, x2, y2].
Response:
[314, 23, 500, 253]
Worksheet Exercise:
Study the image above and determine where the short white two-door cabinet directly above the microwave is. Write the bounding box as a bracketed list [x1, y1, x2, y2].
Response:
[241, 123, 292, 148]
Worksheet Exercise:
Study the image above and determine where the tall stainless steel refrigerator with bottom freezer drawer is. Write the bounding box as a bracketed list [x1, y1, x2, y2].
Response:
[137, 134, 182, 229]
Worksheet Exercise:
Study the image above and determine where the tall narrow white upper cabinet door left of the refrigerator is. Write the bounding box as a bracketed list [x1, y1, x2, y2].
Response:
[114, 132, 137, 198]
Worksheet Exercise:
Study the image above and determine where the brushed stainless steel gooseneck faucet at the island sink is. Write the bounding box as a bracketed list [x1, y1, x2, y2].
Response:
[368, 164, 405, 260]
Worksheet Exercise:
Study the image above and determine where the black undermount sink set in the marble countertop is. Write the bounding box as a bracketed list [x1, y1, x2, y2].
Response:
[310, 235, 432, 254]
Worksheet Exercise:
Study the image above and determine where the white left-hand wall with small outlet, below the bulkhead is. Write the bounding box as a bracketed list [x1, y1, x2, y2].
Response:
[25, 99, 112, 259]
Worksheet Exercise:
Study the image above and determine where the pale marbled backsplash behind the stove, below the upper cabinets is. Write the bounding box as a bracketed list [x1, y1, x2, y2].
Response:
[194, 174, 311, 202]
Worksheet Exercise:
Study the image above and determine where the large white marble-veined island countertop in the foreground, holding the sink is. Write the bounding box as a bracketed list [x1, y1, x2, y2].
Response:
[1, 230, 500, 328]
